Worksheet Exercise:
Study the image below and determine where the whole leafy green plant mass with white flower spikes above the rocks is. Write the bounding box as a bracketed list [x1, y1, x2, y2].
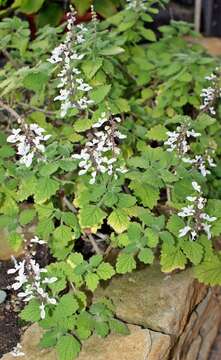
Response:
[0, 0, 221, 360]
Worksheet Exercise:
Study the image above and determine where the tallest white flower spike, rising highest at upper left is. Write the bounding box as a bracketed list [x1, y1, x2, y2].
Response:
[48, 9, 93, 117]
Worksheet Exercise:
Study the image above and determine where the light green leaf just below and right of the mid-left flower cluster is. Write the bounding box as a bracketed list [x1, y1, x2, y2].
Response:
[35, 177, 59, 204]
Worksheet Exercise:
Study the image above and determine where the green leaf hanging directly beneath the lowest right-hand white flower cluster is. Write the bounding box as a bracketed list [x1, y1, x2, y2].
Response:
[180, 239, 204, 265]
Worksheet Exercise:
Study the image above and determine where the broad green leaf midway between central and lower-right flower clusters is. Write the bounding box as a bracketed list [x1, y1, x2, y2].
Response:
[129, 181, 160, 209]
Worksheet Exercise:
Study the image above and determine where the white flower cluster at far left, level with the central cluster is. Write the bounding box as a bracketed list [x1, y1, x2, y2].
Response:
[7, 124, 51, 167]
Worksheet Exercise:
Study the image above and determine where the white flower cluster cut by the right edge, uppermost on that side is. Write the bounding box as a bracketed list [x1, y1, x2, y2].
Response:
[200, 68, 221, 115]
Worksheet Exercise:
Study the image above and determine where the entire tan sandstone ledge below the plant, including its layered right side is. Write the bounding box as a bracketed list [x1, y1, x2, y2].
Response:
[2, 265, 221, 360]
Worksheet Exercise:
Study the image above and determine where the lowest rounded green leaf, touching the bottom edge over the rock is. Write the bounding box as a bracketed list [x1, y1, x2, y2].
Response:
[56, 335, 81, 360]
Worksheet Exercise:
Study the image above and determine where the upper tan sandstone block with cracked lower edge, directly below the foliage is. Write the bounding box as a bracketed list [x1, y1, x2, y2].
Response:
[95, 264, 207, 337]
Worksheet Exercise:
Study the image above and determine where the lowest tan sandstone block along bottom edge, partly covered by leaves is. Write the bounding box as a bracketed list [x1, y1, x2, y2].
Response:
[2, 325, 170, 360]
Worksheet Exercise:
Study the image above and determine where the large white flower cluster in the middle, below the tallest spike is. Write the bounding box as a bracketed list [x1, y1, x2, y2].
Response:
[73, 113, 127, 184]
